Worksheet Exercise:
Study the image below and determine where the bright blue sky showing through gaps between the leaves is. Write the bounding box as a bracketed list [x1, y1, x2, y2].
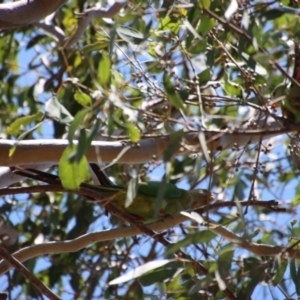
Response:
[0, 4, 299, 299]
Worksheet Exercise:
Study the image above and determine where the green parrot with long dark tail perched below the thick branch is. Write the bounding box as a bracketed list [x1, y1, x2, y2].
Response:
[13, 168, 214, 223]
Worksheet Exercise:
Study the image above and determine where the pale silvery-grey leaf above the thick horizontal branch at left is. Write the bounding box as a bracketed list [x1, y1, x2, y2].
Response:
[45, 96, 74, 124]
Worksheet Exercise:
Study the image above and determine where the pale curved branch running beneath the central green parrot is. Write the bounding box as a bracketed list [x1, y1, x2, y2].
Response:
[0, 201, 300, 274]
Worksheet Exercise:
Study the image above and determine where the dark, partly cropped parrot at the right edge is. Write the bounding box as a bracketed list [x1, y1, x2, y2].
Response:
[272, 42, 300, 123]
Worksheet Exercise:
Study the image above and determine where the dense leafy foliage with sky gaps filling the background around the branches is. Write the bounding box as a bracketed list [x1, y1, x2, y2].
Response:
[0, 0, 300, 299]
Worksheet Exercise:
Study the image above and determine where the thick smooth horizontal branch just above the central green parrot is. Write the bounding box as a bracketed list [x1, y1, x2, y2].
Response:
[0, 122, 300, 166]
